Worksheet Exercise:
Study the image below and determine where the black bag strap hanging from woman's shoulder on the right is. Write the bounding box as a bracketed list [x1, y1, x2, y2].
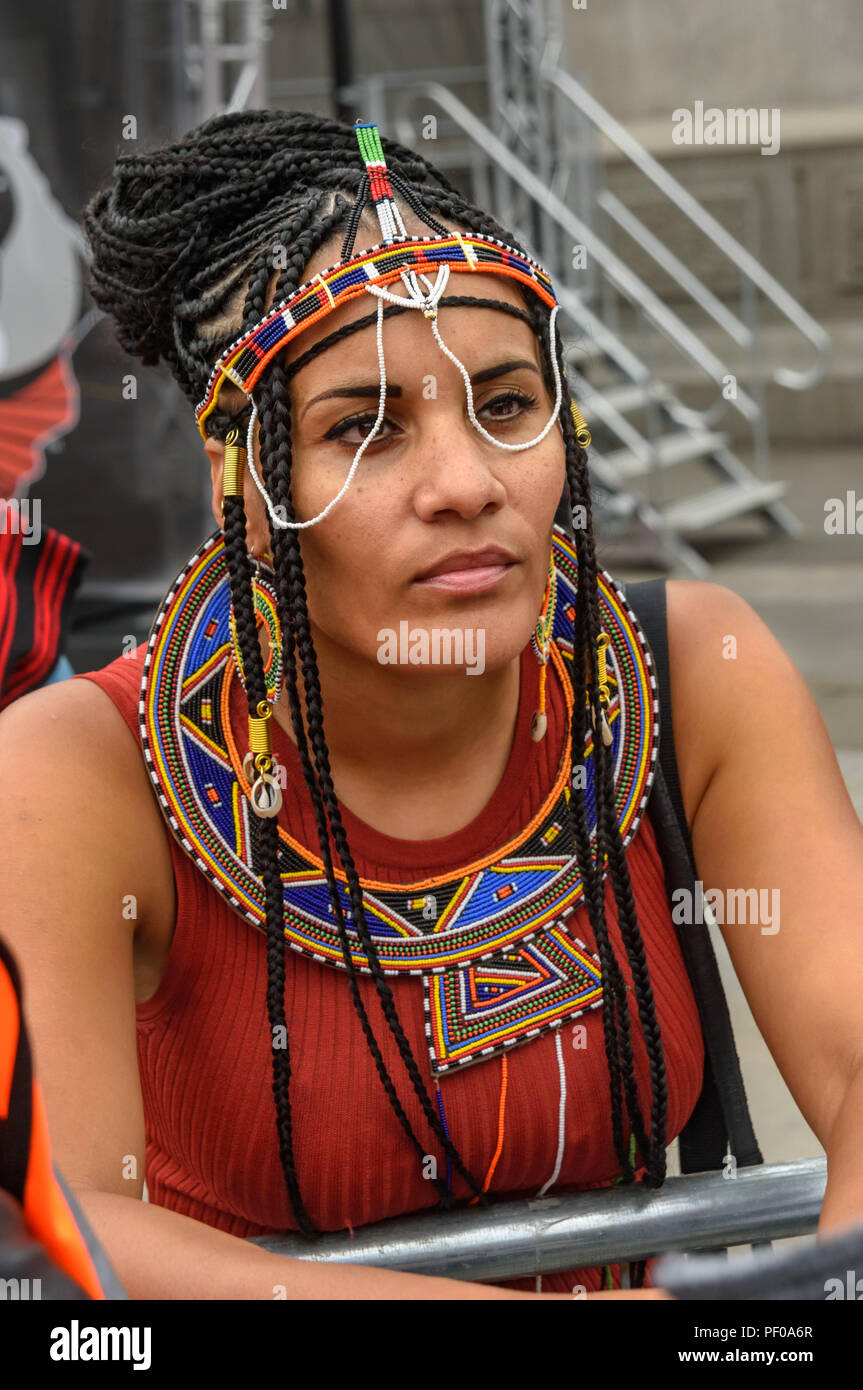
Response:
[625, 578, 763, 1173]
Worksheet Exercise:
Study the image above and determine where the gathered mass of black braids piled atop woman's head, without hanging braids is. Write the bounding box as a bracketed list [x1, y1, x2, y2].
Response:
[82, 110, 466, 400]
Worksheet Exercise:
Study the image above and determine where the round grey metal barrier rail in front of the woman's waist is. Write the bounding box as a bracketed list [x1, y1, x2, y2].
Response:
[253, 1158, 827, 1280]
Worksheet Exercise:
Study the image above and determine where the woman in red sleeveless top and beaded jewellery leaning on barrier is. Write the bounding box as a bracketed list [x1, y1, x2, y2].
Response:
[0, 113, 863, 1298]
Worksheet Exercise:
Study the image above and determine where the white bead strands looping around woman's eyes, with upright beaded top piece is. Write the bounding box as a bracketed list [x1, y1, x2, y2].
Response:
[225, 121, 563, 531]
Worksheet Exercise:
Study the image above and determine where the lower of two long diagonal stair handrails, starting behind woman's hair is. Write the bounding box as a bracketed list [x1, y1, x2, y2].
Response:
[397, 82, 759, 420]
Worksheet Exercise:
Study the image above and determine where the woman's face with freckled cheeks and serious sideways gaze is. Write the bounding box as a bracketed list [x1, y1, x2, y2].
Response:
[214, 223, 566, 676]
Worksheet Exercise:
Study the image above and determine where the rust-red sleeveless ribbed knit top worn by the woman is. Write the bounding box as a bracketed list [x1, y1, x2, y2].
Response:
[77, 645, 703, 1291]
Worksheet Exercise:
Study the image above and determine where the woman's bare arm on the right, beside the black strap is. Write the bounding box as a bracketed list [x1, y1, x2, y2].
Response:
[668, 581, 863, 1232]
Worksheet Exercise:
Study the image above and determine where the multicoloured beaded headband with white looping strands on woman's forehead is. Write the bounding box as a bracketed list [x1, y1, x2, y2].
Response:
[195, 121, 578, 530]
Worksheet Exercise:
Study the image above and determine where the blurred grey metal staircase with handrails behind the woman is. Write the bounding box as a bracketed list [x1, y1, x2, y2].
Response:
[356, 0, 830, 577]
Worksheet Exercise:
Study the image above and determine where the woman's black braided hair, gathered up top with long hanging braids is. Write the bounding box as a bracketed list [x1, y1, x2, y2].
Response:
[83, 111, 667, 1283]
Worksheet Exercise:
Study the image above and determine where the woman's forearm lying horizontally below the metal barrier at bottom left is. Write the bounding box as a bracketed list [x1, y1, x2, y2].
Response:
[75, 1187, 536, 1300]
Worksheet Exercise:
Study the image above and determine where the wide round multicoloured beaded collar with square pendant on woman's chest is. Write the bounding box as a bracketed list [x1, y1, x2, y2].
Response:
[140, 528, 659, 1073]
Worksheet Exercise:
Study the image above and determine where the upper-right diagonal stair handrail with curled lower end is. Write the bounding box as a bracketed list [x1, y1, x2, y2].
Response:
[541, 67, 832, 391]
